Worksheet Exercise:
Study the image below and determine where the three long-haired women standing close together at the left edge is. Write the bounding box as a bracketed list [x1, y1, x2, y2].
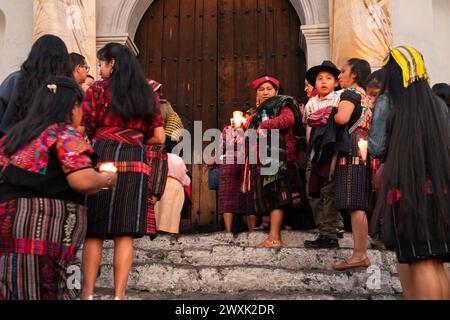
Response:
[0, 35, 165, 300]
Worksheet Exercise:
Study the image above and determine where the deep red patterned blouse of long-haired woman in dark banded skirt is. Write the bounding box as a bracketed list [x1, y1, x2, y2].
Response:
[82, 80, 164, 140]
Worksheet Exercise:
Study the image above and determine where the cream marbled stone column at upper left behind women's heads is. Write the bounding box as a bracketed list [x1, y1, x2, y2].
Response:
[33, 0, 97, 73]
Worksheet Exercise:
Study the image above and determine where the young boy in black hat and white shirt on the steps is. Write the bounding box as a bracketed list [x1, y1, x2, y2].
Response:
[303, 61, 344, 248]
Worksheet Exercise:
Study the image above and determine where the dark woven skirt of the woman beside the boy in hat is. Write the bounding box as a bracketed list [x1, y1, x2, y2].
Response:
[335, 132, 372, 212]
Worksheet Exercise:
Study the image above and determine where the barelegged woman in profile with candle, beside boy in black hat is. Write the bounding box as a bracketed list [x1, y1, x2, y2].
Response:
[334, 59, 371, 270]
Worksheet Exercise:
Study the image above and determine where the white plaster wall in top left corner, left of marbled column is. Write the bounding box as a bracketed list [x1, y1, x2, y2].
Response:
[0, 0, 33, 81]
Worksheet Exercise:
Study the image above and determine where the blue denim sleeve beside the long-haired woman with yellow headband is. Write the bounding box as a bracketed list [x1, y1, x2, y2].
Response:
[369, 94, 391, 159]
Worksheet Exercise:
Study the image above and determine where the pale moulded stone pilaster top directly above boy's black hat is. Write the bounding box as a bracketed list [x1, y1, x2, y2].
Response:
[301, 23, 330, 69]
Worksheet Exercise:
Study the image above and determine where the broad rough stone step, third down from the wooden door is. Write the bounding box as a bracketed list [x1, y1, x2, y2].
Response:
[96, 263, 401, 296]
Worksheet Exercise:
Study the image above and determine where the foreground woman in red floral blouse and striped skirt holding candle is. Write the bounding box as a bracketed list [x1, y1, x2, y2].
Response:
[0, 77, 116, 300]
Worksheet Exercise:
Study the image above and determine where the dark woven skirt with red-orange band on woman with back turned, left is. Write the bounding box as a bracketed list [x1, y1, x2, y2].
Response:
[86, 140, 149, 239]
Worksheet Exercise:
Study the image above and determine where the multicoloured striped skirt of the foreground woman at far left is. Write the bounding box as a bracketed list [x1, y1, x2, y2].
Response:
[0, 198, 87, 300]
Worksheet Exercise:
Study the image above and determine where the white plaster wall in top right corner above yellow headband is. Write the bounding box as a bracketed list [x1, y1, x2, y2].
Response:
[392, 0, 450, 83]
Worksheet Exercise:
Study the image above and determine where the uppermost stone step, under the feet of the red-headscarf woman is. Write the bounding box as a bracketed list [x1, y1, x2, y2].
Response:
[101, 231, 366, 250]
